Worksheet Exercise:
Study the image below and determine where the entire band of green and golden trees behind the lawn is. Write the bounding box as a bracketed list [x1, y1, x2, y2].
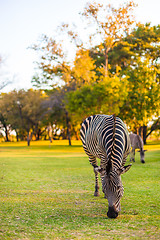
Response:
[0, 1, 160, 144]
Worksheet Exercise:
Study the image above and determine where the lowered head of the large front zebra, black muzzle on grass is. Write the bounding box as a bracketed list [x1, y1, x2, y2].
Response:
[102, 160, 131, 218]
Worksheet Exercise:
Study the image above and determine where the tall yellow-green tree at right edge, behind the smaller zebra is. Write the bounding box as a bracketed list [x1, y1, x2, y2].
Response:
[117, 24, 160, 143]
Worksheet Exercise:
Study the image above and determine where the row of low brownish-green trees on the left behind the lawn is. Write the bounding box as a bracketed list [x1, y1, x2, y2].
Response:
[0, 89, 71, 146]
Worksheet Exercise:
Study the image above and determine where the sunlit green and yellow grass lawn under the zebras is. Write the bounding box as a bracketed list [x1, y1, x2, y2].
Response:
[0, 141, 160, 240]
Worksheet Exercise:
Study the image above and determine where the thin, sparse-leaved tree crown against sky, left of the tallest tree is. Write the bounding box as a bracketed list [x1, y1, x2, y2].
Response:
[32, 35, 71, 89]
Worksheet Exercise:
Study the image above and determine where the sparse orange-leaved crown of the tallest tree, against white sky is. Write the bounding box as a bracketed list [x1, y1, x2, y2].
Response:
[82, 1, 136, 77]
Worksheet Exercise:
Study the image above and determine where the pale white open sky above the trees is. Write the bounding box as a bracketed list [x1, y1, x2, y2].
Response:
[0, 0, 160, 92]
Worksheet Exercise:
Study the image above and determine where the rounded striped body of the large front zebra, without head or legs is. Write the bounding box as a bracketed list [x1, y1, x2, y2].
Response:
[80, 115, 130, 168]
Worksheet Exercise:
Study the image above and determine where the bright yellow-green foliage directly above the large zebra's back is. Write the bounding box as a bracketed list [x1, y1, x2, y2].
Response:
[67, 71, 127, 121]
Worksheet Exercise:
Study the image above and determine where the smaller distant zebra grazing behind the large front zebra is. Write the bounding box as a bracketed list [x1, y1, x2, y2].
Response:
[129, 133, 147, 163]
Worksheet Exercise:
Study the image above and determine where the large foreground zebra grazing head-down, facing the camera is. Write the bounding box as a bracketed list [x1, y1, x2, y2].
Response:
[80, 115, 131, 218]
